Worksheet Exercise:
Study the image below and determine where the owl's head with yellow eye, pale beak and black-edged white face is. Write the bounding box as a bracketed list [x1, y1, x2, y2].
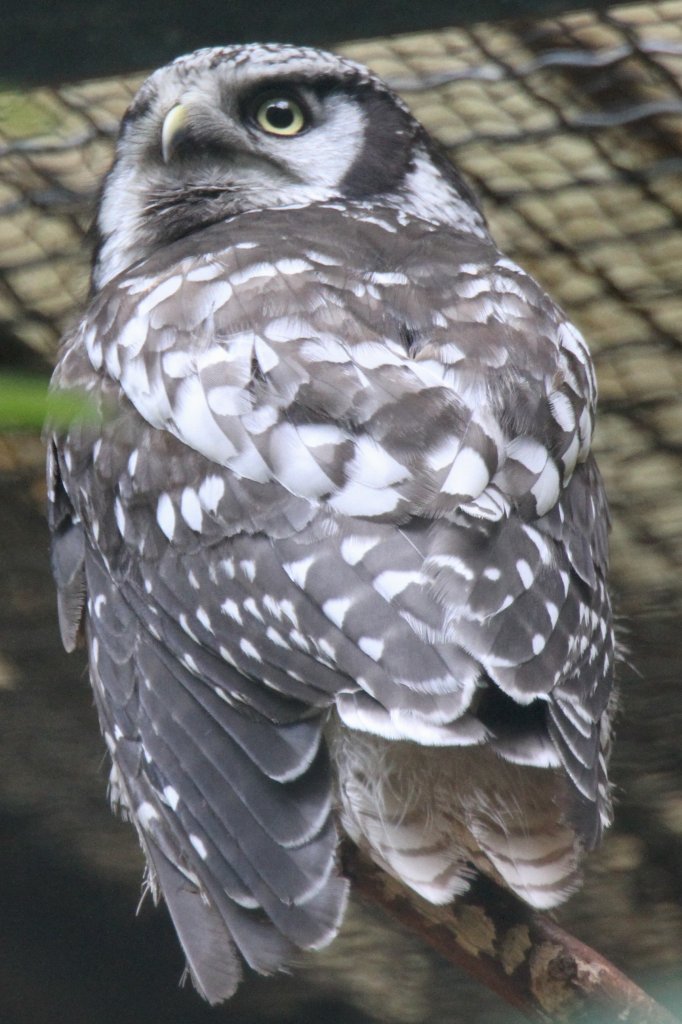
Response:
[93, 45, 483, 290]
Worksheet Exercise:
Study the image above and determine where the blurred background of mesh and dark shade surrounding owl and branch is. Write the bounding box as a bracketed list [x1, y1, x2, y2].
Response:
[0, 0, 682, 1024]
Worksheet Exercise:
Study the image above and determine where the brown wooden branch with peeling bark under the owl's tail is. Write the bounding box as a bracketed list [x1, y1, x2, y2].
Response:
[343, 845, 680, 1024]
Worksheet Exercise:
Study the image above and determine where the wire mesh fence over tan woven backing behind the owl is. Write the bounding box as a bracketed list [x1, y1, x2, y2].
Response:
[0, 0, 682, 608]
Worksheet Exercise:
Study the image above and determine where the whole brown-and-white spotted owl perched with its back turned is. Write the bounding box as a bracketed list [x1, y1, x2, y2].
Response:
[48, 45, 614, 1002]
